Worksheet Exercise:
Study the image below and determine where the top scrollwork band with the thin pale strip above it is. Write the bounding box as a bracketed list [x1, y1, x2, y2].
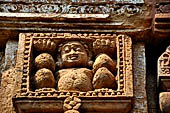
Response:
[0, 0, 144, 15]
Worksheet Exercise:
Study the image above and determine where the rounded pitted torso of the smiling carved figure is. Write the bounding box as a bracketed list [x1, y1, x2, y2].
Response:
[58, 68, 93, 91]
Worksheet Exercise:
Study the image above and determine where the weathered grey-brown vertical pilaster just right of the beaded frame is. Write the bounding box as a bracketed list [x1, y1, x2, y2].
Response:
[131, 43, 148, 113]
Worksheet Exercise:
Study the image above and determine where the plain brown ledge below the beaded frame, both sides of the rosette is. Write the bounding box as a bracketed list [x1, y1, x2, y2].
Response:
[14, 99, 131, 113]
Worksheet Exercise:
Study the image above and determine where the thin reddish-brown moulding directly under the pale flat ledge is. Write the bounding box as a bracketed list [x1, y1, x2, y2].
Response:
[0, 21, 136, 30]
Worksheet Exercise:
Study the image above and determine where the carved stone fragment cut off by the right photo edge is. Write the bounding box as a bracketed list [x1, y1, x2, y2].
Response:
[158, 45, 170, 113]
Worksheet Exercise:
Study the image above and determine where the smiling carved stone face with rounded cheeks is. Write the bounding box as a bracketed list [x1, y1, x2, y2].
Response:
[61, 41, 88, 68]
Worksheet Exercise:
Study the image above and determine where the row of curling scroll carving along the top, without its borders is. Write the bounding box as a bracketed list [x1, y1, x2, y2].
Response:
[0, 3, 142, 15]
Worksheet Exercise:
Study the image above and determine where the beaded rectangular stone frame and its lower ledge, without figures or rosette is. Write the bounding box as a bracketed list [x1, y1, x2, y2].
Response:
[13, 33, 133, 113]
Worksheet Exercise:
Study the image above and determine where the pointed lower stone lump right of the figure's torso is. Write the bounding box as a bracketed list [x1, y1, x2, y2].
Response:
[92, 67, 116, 89]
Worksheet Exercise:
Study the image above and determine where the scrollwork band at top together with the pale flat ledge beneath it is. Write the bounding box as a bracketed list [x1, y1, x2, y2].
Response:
[0, 0, 144, 21]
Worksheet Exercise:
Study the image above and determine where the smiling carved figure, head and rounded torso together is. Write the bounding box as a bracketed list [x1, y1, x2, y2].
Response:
[57, 41, 93, 91]
